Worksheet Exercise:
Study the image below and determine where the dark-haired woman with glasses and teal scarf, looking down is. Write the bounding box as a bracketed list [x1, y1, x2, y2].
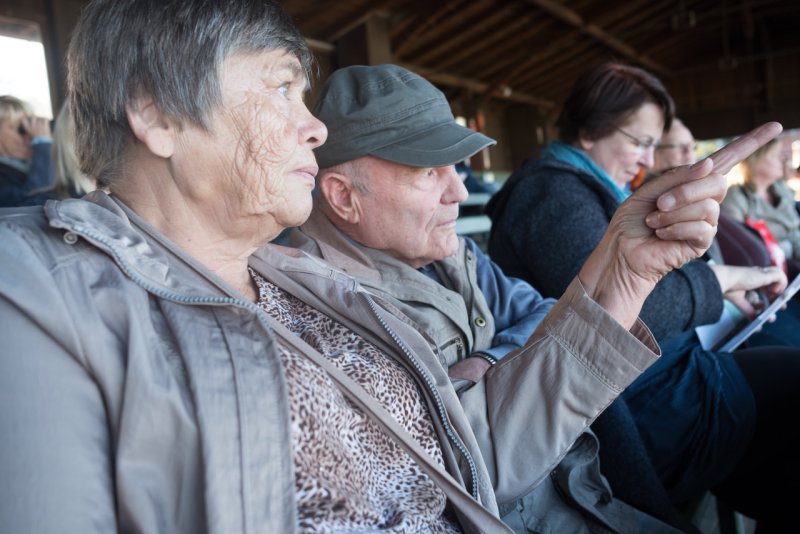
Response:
[487, 63, 800, 528]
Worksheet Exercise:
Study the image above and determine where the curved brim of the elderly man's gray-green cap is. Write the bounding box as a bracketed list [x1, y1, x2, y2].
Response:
[370, 122, 497, 167]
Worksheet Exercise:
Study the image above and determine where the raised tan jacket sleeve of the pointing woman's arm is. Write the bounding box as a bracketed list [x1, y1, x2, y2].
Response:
[461, 278, 660, 503]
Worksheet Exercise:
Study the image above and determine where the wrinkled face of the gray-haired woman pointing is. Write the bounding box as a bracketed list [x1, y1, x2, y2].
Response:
[173, 50, 327, 237]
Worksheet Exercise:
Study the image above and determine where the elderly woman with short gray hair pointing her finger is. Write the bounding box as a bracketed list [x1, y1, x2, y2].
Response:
[0, 0, 778, 533]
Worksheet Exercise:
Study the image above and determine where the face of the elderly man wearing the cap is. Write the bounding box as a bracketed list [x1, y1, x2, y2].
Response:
[353, 156, 468, 269]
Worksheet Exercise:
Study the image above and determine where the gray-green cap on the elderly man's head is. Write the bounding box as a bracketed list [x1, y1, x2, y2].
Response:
[312, 65, 496, 169]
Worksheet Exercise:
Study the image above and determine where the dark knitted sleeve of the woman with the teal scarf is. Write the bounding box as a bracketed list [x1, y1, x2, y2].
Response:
[492, 164, 722, 340]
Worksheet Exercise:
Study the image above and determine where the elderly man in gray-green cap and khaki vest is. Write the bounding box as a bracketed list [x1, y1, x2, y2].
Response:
[291, 65, 728, 532]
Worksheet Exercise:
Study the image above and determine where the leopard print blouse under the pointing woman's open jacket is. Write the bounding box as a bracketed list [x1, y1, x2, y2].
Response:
[251, 270, 459, 533]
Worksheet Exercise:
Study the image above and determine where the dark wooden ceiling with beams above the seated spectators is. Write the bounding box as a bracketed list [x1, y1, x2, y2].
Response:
[282, 0, 800, 138]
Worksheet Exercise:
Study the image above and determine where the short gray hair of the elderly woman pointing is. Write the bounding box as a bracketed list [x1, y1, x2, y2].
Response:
[67, 0, 312, 185]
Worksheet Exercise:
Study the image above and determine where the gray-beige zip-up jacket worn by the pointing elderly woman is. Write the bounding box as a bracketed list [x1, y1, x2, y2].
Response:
[0, 192, 658, 533]
